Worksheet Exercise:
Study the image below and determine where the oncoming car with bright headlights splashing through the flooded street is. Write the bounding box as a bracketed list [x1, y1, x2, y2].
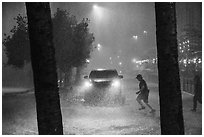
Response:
[83, 69, 125, 105]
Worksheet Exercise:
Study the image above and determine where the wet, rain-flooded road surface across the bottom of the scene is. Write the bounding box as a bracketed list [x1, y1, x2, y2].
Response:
[2, 79, 202, 135]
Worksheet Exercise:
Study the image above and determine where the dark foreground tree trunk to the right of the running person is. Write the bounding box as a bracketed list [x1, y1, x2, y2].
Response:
[155, 2, 184, 135]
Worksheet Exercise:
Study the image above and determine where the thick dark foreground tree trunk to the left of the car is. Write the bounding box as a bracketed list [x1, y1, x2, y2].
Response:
[26, 3, 63, 135]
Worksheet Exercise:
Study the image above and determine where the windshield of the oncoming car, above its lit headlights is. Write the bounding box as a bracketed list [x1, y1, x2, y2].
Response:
[89, 70, 118, 78]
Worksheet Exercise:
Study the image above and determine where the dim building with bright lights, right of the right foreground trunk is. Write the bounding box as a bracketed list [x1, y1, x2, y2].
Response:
[176, 2, 202, 71]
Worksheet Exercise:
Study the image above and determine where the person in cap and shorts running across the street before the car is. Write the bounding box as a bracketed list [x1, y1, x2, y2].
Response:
[136, 74, 155, 113]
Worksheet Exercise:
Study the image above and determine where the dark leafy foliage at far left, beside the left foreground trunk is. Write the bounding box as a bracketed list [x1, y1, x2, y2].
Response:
[3, 14, 30, 69]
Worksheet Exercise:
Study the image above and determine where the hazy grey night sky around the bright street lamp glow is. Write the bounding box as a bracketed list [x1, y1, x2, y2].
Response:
[2, 2, 189, 73]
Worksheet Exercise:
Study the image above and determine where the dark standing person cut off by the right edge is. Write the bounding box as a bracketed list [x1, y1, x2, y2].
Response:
[192, 75, 202, 111]
